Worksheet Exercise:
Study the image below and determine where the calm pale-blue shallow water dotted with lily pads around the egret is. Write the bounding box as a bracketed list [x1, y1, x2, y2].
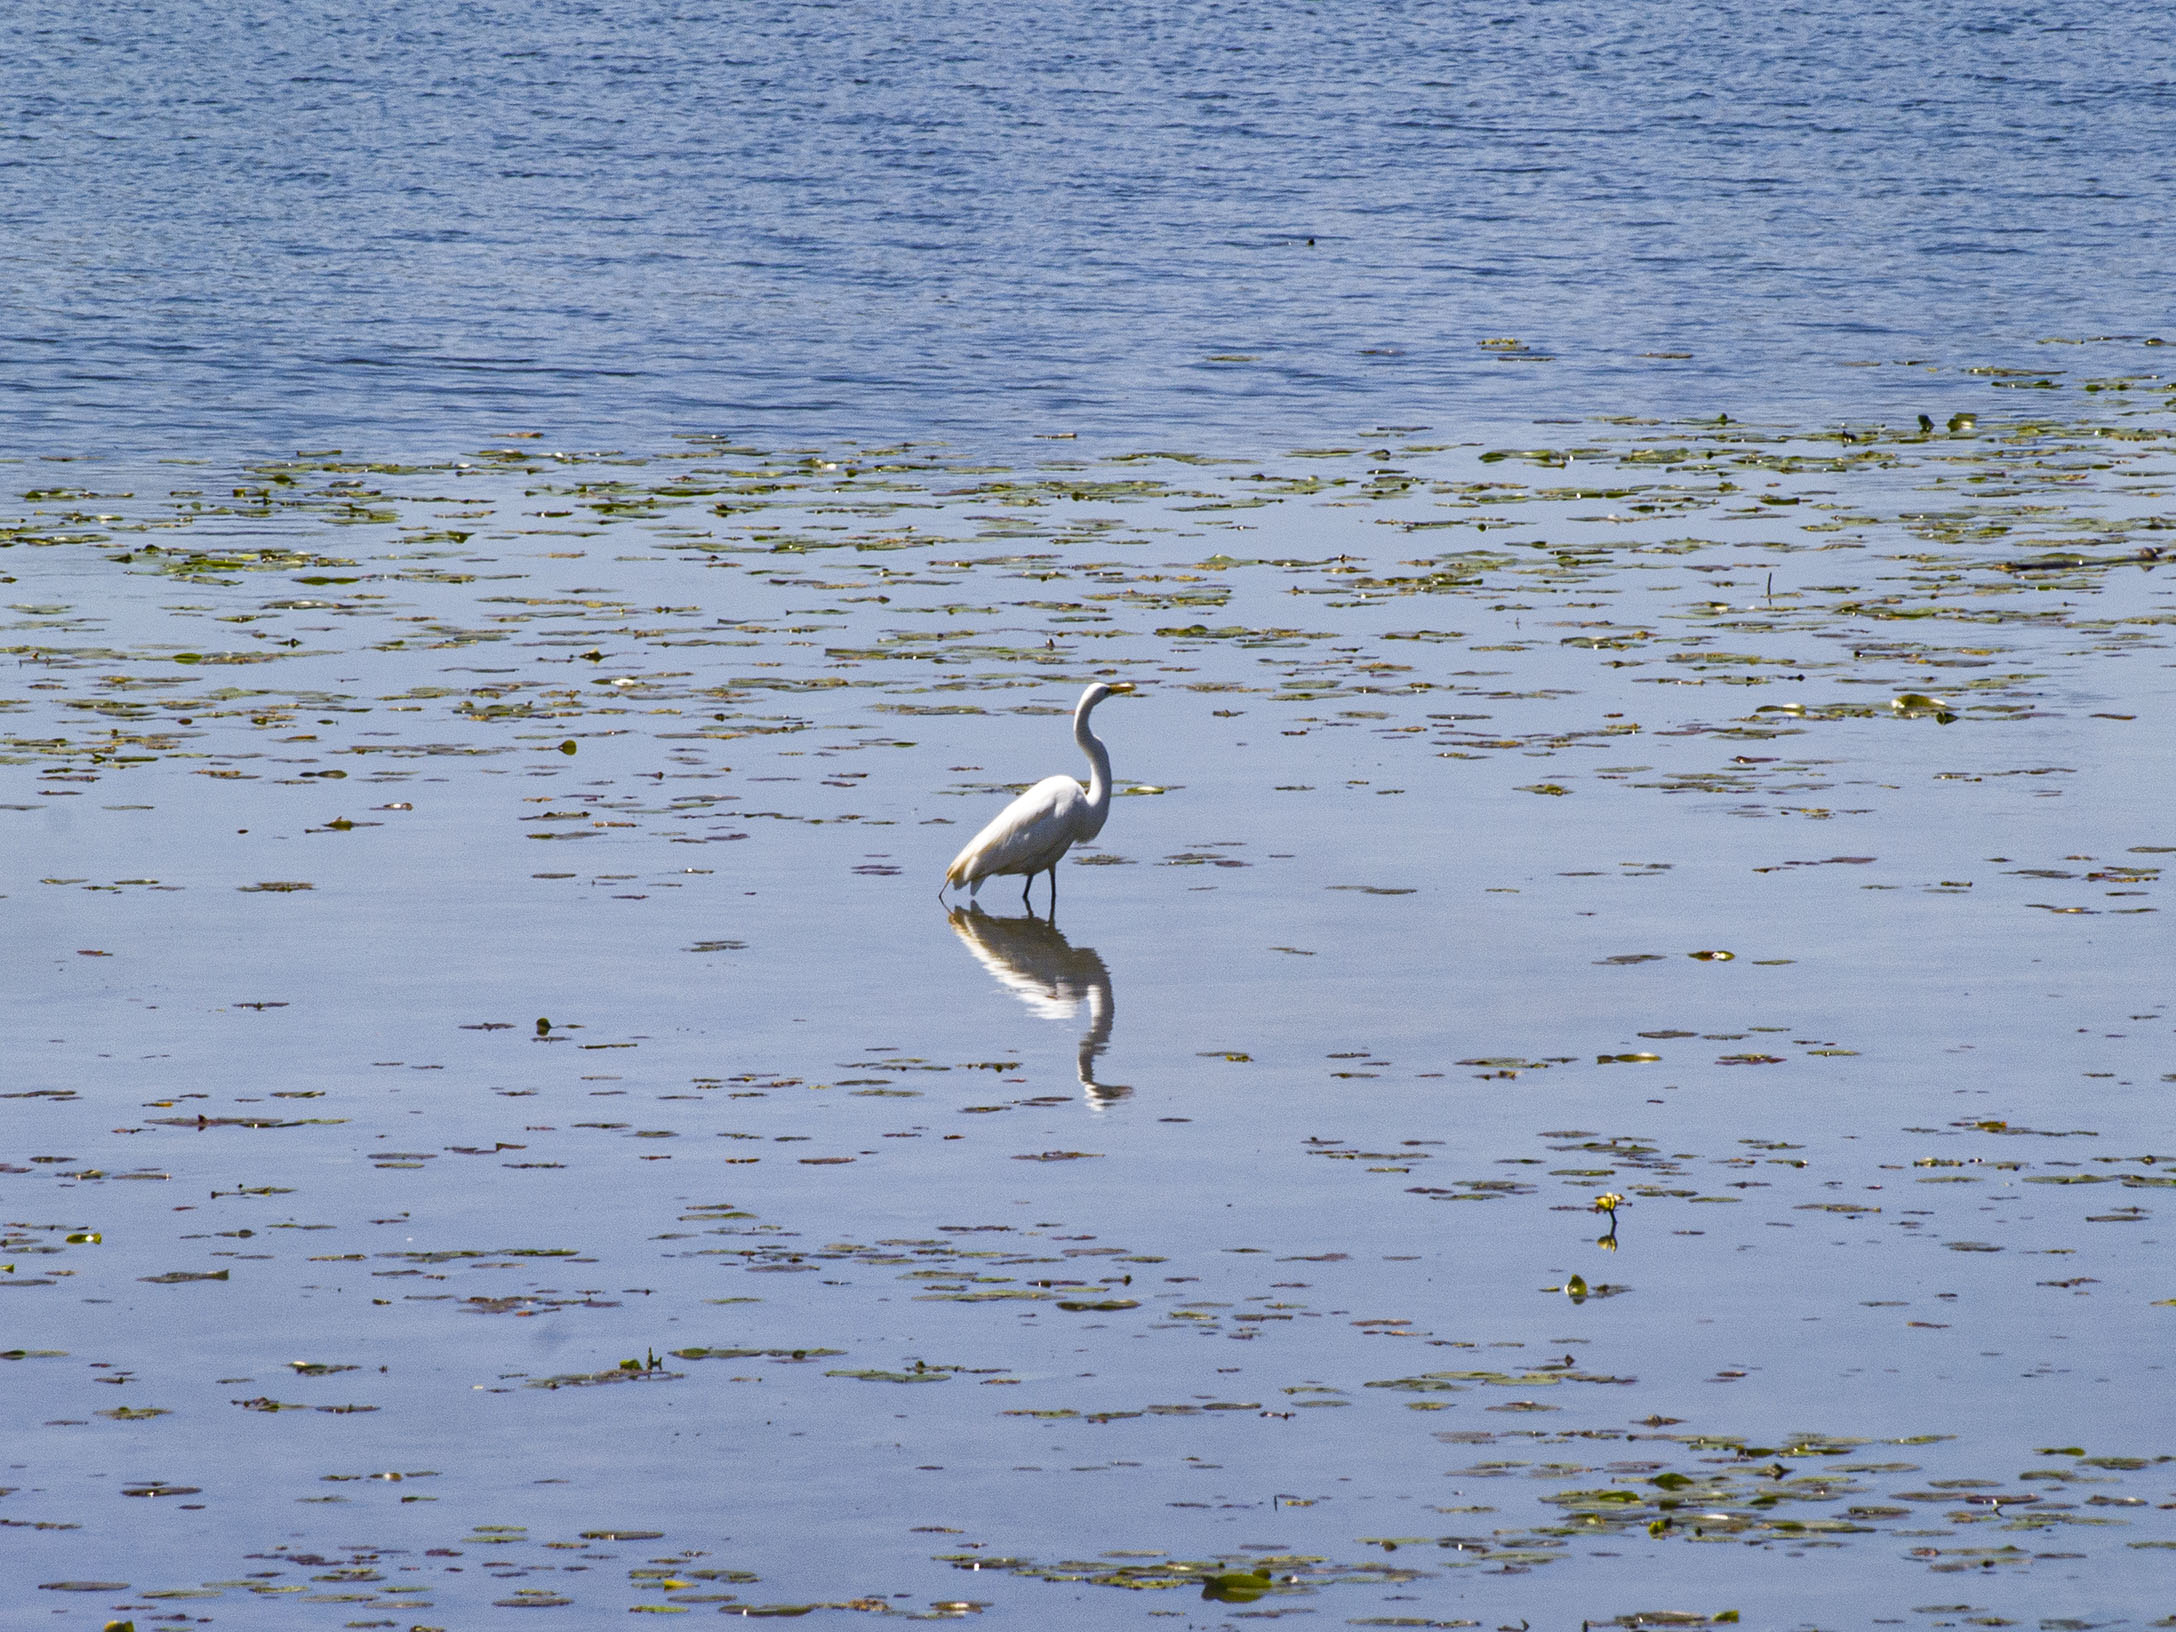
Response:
[12, 406, 2176, 1628]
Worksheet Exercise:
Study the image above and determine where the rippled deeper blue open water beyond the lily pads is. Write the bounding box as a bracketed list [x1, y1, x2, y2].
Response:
[0, 0, 2176, 457]
